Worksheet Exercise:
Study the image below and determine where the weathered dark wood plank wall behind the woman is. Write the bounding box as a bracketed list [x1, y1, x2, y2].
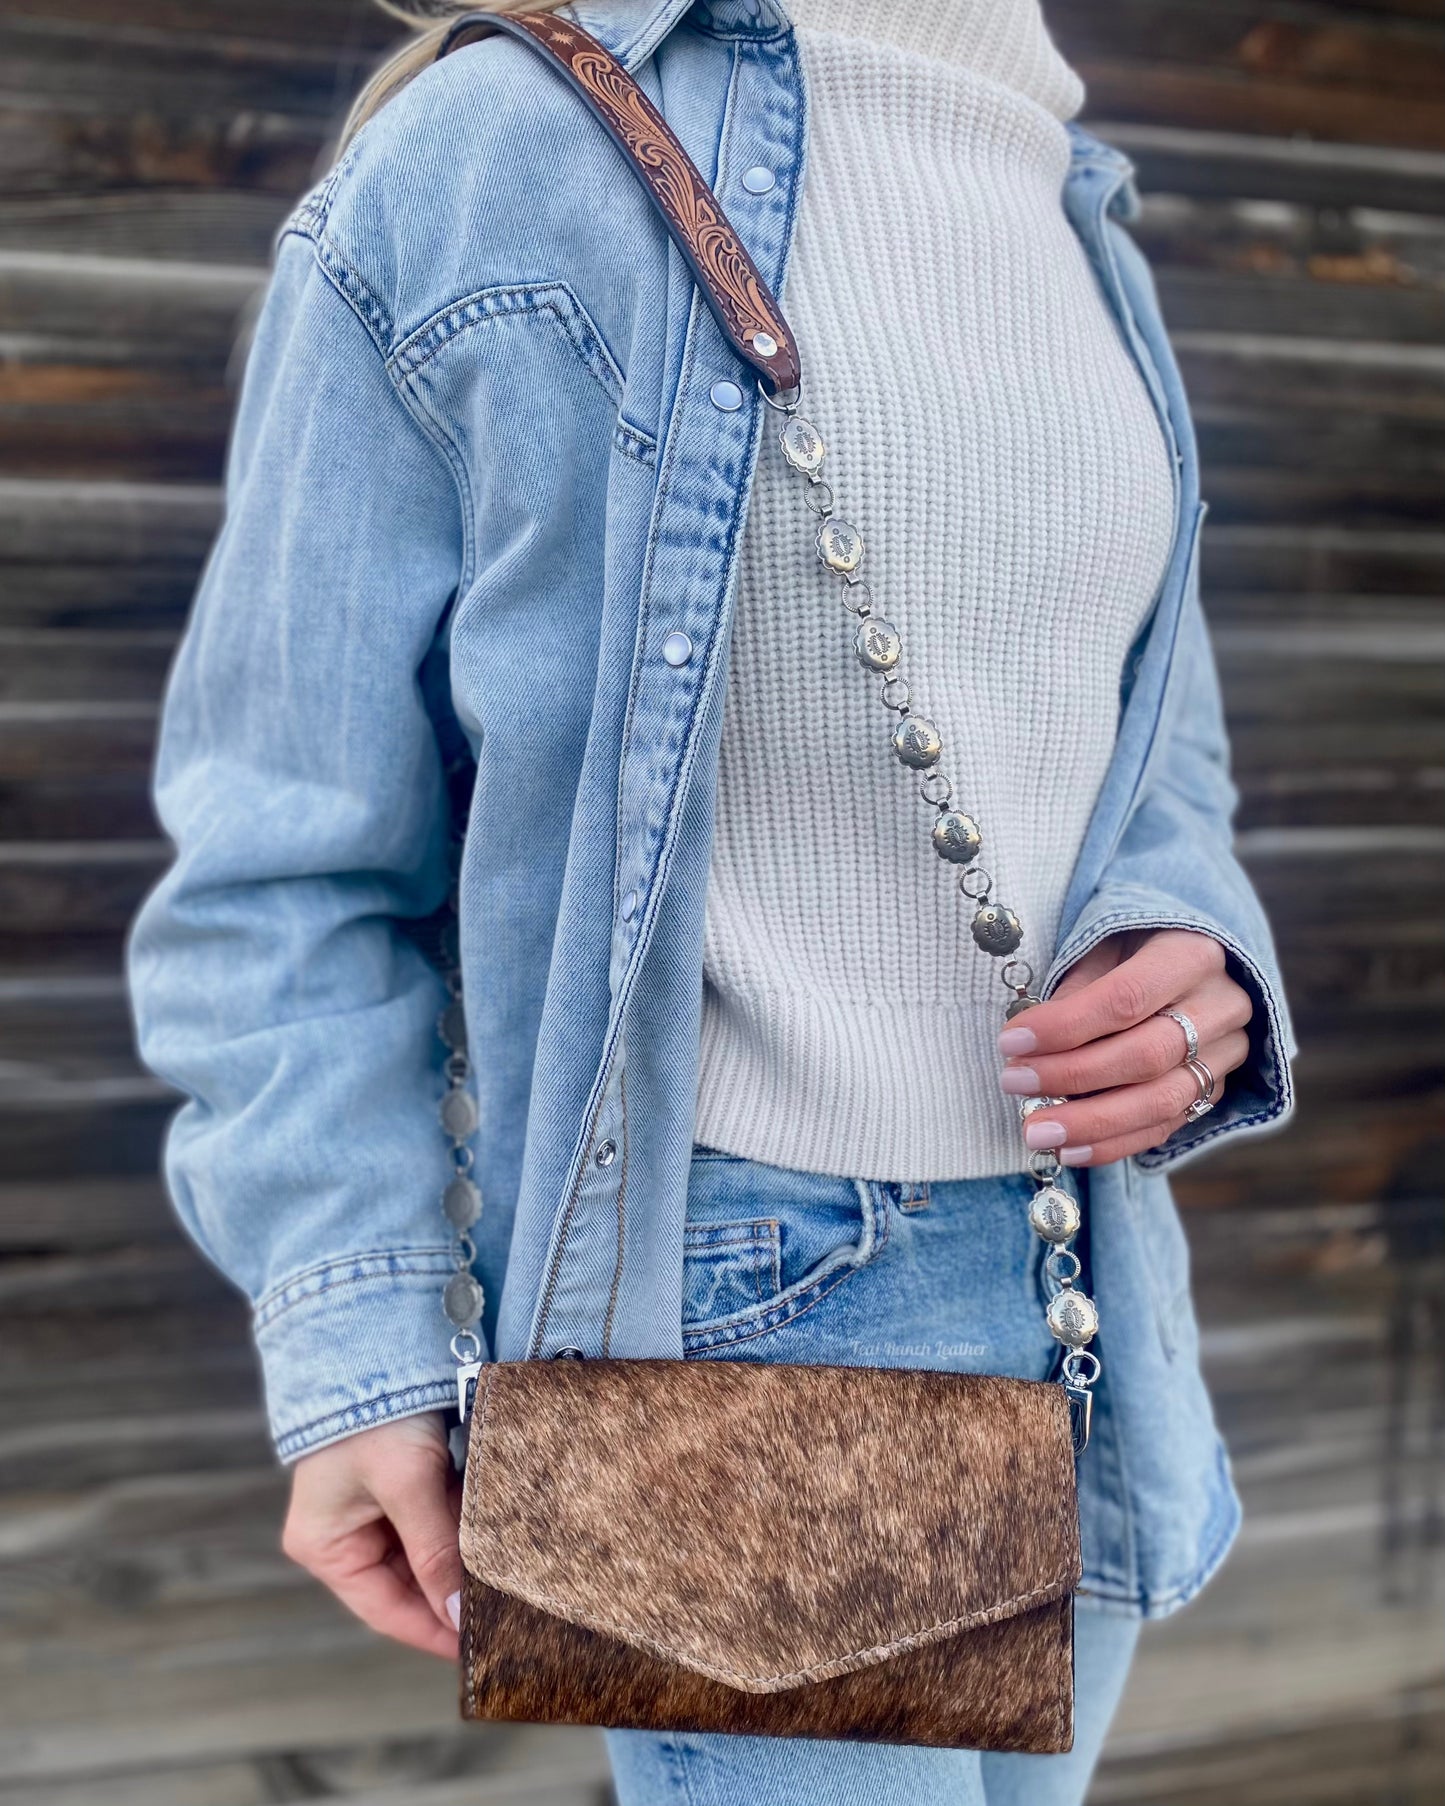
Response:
[0, 0, 1445, 1806]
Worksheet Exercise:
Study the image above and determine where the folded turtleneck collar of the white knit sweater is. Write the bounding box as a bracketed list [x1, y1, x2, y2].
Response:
[784, 0, 1084, 119]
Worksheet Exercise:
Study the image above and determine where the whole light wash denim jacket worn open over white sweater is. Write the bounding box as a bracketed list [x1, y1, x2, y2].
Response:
[130, 0, 1293, 1613]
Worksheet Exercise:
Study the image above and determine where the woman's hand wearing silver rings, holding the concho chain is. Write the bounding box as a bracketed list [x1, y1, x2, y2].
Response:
[999, 928, 1254, 1167]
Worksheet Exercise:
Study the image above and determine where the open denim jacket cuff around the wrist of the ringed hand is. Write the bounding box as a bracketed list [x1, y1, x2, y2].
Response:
[1042, 889, 1297, 1170]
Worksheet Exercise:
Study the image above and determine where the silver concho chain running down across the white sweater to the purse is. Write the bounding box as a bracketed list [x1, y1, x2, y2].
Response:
[753, 370, 1102, 1448]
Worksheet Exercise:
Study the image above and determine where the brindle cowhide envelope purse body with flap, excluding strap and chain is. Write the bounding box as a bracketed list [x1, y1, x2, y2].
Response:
[461, 1362, 1080, 1754]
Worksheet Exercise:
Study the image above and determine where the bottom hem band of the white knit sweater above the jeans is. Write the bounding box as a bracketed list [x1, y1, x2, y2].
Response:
[695, 990, 1024, 1181]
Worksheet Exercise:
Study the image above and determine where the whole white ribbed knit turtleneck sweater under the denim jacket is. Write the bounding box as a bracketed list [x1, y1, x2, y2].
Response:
[697, 0, 1174, 1179]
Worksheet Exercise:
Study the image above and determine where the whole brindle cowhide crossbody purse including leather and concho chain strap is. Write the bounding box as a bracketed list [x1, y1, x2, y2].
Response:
[441, 13, 1100, 1754]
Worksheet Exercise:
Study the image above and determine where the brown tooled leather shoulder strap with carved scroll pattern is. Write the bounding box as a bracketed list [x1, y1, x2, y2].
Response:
[437, 13, 802, 394]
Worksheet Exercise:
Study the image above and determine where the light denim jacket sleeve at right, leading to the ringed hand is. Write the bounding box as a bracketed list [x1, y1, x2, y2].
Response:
[1046, 549, 1297, 1167]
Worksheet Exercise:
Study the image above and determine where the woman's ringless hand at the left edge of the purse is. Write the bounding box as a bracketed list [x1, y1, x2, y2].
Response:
[282, 1412, 462, 1662]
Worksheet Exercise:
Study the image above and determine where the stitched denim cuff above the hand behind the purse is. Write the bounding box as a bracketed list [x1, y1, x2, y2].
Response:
[255, 1248, 457, 1463]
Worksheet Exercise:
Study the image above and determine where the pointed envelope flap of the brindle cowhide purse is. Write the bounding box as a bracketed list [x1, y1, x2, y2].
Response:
[461, 1360, 1080, 1692]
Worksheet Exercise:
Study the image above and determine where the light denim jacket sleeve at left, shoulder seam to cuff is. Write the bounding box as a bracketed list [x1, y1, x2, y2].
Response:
[130, 222, 466, 1456]
